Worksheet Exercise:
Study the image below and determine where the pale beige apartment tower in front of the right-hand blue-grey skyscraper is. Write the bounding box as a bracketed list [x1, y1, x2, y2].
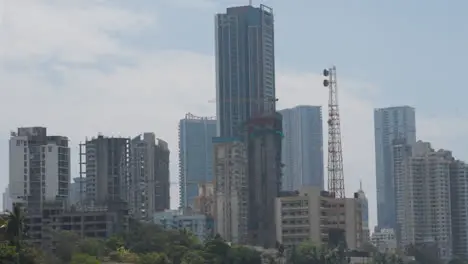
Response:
[393, 141, 454, 260]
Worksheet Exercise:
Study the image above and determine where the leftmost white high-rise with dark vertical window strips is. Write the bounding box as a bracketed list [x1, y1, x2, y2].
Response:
[9, 127, 70, 203]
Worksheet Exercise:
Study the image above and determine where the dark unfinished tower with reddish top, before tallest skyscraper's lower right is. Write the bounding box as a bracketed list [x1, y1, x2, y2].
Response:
[244, 113, 283, 248]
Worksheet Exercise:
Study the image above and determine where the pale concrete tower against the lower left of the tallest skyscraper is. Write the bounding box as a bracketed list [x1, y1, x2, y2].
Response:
[213, 138, 249, 244]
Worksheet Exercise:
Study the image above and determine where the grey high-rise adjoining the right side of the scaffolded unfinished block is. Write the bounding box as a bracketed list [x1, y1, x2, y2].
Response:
[128, 133, 170, 220]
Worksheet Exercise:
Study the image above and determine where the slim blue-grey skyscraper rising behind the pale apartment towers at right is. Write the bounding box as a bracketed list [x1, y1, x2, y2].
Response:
[374, 106, 416, 229]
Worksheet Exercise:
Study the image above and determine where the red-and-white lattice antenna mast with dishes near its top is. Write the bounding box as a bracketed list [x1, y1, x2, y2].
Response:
[323, 66, 345, 198]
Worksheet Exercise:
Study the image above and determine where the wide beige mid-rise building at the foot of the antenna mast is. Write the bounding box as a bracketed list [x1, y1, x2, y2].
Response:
[275, 187, 362, 249]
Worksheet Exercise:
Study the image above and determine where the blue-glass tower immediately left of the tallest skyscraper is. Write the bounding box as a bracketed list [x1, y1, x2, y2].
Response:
[179, 114, 216, 208]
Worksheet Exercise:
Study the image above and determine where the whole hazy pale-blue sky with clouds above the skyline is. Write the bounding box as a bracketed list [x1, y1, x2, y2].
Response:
[0, 0, 468, 230]
